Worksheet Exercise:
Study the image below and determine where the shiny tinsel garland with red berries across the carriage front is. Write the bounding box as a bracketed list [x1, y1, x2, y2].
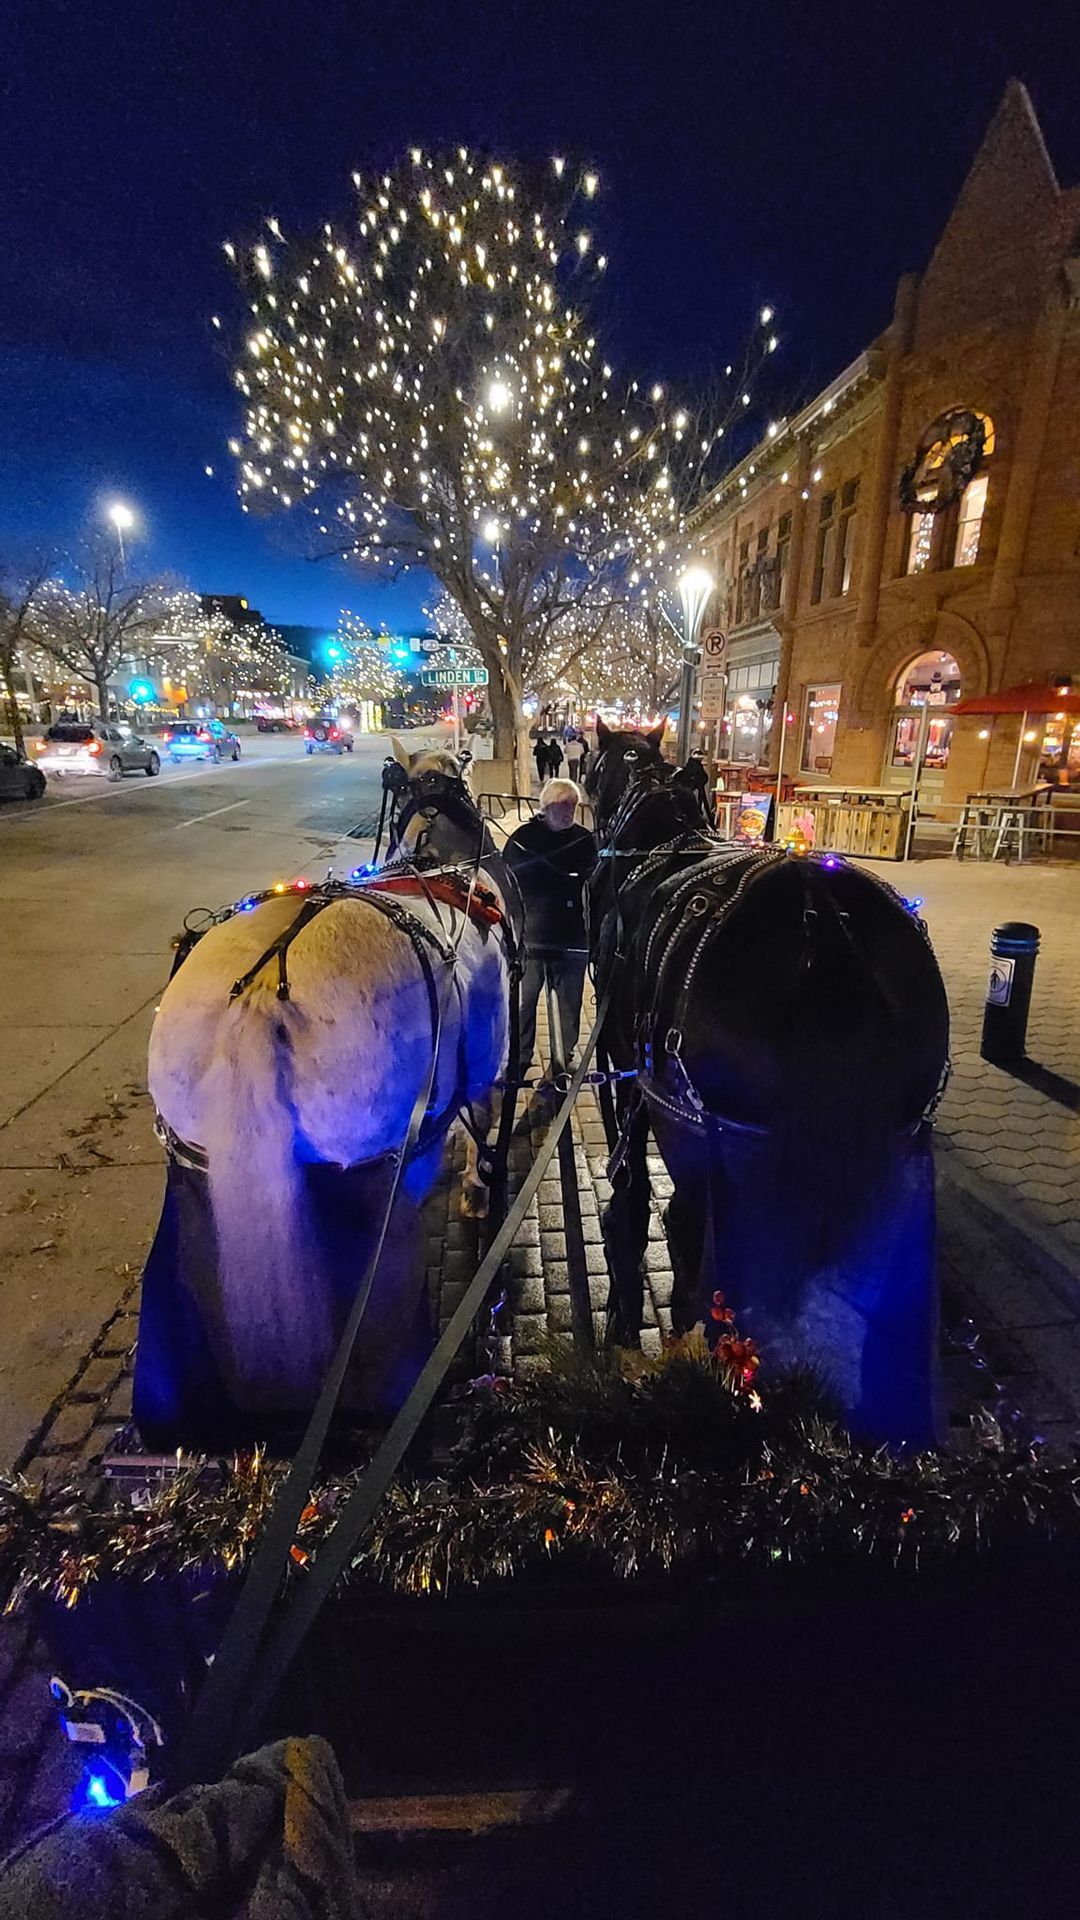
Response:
[0, 1344, 1080, 1609]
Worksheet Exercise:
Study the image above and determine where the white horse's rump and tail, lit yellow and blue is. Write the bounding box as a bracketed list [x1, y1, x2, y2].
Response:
[150, 895, 507, 1413]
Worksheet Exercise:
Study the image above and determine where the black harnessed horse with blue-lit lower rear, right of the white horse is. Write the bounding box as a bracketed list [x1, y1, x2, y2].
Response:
[588, 726, 949, 1444]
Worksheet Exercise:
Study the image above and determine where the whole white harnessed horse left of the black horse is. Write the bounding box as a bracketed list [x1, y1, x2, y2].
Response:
[136, 747, 509, 1438]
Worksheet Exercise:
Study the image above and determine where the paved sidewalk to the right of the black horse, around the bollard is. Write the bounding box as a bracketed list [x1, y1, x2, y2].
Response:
[868, 860, 1080, 1430]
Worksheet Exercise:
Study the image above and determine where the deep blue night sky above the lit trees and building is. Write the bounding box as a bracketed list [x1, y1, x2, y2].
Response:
[0, 0, 1080, 626]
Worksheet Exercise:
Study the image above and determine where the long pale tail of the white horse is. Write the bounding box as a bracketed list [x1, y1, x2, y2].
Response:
[195, 987, 331, 1411]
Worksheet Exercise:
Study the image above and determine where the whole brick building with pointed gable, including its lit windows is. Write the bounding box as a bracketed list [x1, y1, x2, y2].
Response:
[684, 83, 1080, 801]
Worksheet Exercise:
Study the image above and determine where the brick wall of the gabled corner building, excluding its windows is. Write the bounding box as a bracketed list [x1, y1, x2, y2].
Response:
[687, 84, 1080, 799]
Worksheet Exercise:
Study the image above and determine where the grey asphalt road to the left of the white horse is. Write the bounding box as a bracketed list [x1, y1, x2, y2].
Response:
[0, 733, 401, 1467]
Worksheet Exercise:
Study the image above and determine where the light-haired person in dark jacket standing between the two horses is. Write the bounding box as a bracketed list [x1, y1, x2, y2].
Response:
[505, 780, 596, 1079]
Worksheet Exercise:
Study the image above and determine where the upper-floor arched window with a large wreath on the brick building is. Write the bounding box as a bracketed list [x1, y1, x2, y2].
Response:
[899, 407, 995, 574]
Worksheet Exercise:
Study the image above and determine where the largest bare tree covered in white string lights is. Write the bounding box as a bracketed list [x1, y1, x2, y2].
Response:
[227, 148, 776, 778]
